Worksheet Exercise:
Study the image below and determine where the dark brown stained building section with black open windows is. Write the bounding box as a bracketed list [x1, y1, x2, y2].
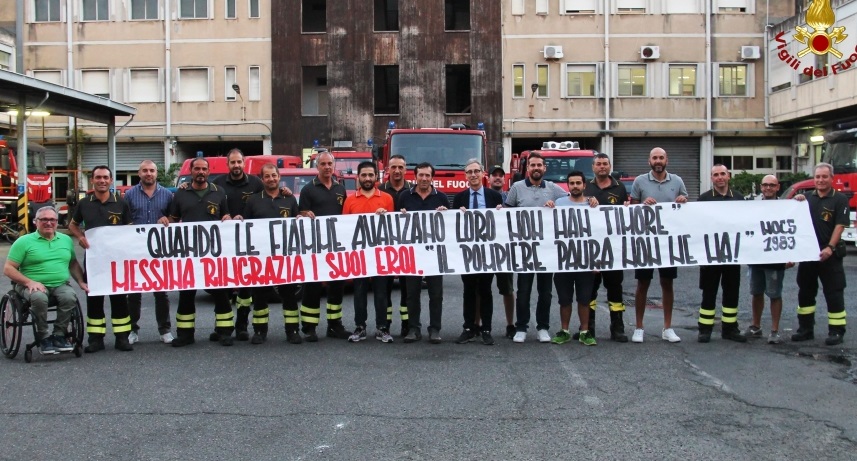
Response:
[272, 0, 503, 162]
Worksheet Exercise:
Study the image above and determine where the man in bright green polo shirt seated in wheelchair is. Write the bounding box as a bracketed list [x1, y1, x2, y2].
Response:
[3, 206, 89, 355]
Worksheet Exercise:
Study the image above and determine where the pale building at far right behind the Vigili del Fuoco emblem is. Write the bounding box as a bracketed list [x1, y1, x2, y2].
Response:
[767, 0, 857, 162]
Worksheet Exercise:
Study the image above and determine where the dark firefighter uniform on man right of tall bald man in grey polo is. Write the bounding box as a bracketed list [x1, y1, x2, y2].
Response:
[698, 189, 747, 343]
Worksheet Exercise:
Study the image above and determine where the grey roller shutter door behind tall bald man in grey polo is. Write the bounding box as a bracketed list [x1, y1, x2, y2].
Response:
[613, 137, 701, 200]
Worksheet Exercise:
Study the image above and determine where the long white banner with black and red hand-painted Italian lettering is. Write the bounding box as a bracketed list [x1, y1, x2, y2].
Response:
[86, 200, 819, 295]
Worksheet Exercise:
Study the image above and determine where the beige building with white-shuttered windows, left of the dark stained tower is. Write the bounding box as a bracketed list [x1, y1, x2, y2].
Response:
[0, 0, 271, 192]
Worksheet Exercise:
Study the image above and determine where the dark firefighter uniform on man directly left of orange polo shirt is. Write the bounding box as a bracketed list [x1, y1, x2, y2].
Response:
[299, 177, 351, 342]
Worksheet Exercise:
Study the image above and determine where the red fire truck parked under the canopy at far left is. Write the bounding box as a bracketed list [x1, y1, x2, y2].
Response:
[0, 136, 53, 222]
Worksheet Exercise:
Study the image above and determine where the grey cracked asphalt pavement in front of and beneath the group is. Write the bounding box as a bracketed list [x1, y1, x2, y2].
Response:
[0, 239, 857, 460]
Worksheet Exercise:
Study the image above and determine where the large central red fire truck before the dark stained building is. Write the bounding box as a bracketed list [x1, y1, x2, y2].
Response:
[372, 122, 490, 200]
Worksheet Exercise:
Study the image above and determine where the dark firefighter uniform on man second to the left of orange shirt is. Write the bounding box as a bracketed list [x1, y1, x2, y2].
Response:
[239, 190, 301, 344]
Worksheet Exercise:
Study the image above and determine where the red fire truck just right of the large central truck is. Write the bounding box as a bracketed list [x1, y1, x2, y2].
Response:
[509, 141, 598, 190]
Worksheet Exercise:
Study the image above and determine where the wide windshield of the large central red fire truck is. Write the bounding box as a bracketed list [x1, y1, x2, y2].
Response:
[390, 132, 483, 170]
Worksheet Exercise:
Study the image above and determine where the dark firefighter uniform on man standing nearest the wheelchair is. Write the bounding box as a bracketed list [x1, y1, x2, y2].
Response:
[72, 193, 133, 352]
